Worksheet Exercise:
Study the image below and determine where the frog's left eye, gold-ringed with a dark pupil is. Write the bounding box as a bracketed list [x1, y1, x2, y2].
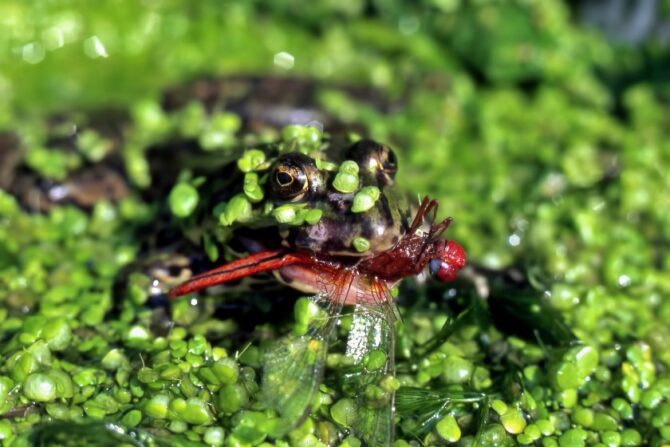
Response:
[271, 153, 316, 202]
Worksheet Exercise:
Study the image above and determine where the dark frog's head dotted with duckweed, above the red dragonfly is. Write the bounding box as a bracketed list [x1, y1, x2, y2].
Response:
[228, 140, 411, 256]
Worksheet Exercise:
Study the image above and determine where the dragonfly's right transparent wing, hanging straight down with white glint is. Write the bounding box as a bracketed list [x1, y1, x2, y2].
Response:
[345, 277, 397, 447]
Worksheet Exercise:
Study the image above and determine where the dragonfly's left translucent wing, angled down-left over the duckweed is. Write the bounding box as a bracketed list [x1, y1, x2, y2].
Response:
[261, 269, 353, 437]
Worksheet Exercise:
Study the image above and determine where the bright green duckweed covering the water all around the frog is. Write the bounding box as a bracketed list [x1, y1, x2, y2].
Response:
[0, 0, 670, 447]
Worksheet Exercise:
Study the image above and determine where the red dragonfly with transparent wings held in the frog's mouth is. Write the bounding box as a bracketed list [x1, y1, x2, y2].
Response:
[169, 198, 466, 446]
